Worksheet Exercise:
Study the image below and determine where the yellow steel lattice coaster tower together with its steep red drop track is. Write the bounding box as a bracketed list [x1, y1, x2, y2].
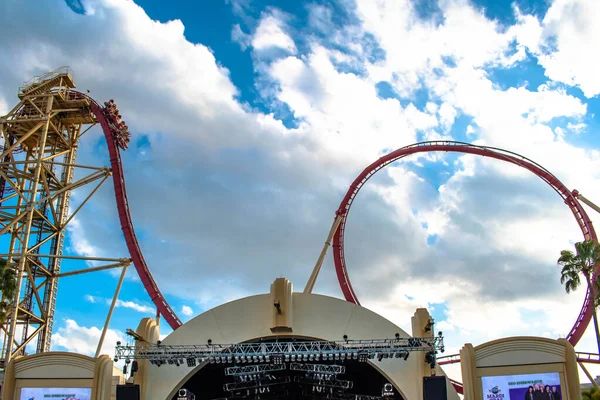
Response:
[0, 67, 181, 368]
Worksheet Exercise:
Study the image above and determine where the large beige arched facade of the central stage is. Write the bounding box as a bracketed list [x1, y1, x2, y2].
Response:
[136, 285, 458, 400]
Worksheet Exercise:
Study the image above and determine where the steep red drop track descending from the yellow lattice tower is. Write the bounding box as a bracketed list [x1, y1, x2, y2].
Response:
[71, 91, 181, 329]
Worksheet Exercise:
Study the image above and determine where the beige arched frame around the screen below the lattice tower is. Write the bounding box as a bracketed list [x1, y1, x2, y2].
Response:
[2, 352, 118, 400]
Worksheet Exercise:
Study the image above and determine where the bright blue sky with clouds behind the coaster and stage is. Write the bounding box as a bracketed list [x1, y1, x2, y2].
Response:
[0, 0, 600, 382]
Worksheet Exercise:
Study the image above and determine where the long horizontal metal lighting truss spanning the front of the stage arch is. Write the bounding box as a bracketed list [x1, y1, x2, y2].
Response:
[115, 336, 444, 364]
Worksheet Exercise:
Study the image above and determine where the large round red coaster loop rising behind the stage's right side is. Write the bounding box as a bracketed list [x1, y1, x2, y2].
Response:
[333, 141, 600, 392]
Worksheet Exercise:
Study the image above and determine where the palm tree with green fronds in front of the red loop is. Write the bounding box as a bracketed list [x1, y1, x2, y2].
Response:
[558, 240, 600, 353]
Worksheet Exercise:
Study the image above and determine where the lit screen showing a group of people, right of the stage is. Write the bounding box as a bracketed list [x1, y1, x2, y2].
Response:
[481, 372, 563, 400]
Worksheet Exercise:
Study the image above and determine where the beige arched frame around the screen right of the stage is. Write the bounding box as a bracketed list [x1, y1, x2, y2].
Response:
[460, 337, 581, 400]
